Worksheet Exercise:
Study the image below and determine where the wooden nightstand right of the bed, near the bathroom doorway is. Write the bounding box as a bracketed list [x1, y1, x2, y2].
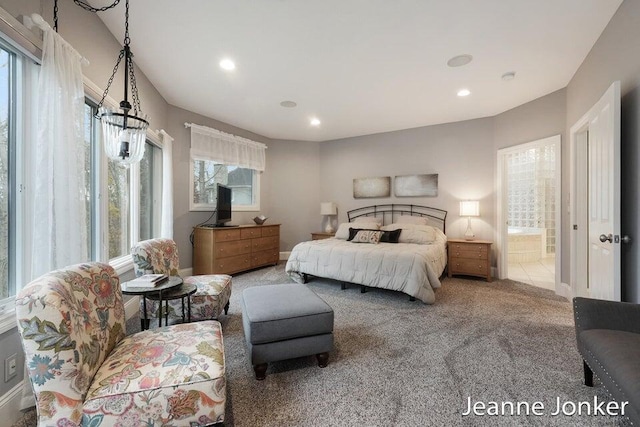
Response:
[447, 239, 493, 282]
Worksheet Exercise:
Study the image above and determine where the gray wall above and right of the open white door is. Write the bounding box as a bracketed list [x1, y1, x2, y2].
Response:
[566, 0, 640, 302]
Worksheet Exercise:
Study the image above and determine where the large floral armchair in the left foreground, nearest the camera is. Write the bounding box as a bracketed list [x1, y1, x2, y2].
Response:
[16, 263, 226, 427]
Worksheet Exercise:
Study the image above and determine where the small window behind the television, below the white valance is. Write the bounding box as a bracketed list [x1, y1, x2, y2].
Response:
[190, 159, 260, 211]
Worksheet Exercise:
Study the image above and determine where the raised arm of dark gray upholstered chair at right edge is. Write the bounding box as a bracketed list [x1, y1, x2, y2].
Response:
[573, 297, 640, 334]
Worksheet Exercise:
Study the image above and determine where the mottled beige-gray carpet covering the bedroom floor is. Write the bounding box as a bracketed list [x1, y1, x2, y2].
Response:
[12, 265, 627, 427]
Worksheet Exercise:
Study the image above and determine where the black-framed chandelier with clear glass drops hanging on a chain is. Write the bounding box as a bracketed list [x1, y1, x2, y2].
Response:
[69, 0, 149, 166]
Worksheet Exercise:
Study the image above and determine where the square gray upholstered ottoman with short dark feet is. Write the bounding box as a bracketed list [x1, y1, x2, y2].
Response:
[242, 283, 333, 380]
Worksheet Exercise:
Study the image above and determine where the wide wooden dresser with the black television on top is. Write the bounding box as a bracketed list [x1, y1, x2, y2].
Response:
[193, 224, 280, 275]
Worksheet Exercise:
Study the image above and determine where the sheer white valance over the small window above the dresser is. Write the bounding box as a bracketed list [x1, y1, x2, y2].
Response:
[185, 123, 267, 172]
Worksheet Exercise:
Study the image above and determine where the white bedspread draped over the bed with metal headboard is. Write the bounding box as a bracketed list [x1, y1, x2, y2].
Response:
[285, 234, 447, 304]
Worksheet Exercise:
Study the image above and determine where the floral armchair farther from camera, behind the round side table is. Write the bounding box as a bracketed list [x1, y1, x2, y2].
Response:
[131, 239, 231, 321]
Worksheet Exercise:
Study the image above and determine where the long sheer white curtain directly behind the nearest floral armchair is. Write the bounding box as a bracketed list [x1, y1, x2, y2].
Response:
[31, 27, 89, 278]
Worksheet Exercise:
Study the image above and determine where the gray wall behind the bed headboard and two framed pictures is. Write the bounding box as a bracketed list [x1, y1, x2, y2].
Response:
[317, 118, 495, 244]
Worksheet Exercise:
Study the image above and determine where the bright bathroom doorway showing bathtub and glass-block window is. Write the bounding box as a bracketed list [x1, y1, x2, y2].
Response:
[498, 135, 561, 291]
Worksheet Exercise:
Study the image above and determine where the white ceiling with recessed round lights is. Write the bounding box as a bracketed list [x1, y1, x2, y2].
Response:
[92, 0, 622, 141]
